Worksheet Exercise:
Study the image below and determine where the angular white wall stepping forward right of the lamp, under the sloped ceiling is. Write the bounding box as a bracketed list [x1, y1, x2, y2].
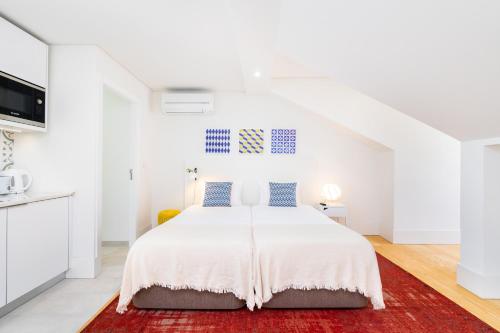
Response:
[273, 79, 460, 243]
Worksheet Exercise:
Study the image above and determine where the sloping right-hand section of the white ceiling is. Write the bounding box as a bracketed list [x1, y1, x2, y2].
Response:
[278, 0, 500, 139]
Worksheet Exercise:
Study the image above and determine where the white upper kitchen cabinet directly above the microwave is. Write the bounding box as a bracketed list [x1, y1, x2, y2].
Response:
[0, 17, 49, 88]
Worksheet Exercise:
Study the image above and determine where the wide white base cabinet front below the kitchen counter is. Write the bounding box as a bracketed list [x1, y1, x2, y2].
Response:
[7, 197, 69, 303]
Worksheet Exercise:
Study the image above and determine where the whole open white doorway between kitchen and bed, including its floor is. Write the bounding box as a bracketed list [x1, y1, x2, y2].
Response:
[98, 86, 136, 266]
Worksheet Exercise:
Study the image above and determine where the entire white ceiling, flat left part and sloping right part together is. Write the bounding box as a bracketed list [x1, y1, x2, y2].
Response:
[0, 0, 500, 139]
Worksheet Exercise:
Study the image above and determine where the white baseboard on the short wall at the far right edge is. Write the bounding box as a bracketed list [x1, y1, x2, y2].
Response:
[457, 263, 500, 299]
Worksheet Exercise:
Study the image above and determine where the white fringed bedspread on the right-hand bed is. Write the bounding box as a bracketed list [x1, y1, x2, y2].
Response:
[252, 206, 385, 309]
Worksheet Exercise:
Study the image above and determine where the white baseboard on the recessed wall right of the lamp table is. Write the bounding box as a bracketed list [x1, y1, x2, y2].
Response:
[393, 229, 460, 244]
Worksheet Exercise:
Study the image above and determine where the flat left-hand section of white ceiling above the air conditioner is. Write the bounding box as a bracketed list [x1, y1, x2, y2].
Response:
[0, 0, 243, 90]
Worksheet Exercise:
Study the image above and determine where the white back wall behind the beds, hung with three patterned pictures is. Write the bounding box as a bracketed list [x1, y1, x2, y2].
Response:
[151, 93, 392, 234]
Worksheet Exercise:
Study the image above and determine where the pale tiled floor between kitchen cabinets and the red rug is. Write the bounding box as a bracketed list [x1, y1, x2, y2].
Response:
[0, 247, 128, 333]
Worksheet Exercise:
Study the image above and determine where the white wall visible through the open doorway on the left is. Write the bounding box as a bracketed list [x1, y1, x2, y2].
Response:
[102, 88, 132, 242]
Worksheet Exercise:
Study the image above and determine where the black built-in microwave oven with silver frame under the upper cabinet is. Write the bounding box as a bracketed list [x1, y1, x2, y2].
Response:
[0, 71, 45, 128]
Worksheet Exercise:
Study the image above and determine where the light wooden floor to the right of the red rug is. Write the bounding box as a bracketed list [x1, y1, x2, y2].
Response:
[367, 236, 500, 331]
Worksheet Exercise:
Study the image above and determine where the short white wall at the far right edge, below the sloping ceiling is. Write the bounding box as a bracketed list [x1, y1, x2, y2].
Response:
[457, 138, 500, 298]
